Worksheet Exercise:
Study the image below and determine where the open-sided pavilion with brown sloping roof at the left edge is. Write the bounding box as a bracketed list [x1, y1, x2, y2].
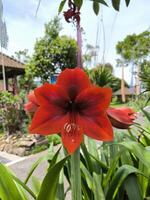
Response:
[0, 53, 25, 94]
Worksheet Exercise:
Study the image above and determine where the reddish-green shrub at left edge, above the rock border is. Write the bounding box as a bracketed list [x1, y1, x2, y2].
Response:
[0, 91, 28, 134]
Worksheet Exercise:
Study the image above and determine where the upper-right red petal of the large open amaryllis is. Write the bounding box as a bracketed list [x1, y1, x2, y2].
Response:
[76, 87, 112, 117]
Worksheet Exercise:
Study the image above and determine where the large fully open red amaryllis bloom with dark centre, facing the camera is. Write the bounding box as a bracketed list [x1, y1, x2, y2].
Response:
[29, 68, 113, 154]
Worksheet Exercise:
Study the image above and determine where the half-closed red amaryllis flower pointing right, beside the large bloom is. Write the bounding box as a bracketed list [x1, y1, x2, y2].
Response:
[107, 107, 136, 129]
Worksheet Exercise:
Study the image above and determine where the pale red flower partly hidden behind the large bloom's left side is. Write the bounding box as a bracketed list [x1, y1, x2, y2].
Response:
[24, 91, 39, 113]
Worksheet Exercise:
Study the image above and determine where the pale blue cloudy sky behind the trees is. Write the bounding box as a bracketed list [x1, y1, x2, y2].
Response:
[2, 0, 150, 83]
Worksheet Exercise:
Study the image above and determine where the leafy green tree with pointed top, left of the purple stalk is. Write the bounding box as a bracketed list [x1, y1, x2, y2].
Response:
[28, 17, 77, 82]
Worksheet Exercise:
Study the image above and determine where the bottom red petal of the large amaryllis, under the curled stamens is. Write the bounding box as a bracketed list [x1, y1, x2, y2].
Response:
[62, 116, 83, 154]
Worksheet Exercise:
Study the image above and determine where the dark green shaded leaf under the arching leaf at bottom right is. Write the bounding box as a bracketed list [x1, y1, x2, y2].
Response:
[124, 174, 143, 200]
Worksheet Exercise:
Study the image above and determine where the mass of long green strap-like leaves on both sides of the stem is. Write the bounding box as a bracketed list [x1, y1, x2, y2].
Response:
[0, 110, 150, 200]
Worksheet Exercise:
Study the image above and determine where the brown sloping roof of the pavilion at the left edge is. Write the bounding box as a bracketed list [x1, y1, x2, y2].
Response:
[0, 53, 25, 79]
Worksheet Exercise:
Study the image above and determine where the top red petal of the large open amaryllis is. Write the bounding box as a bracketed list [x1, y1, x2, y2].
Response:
[57, 67, 91, 99]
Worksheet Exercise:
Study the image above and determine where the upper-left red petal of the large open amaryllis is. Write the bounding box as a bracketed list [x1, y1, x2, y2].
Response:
[35, 83, 69, 107]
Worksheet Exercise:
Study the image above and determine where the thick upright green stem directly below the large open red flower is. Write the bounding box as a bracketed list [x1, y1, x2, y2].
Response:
[71, 148, 82, 200]
